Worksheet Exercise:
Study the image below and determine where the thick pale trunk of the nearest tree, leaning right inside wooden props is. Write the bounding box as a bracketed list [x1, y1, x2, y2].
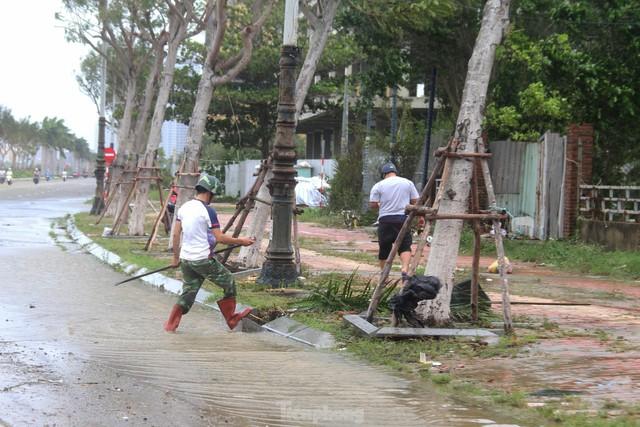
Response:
[420, 0, 510, 324]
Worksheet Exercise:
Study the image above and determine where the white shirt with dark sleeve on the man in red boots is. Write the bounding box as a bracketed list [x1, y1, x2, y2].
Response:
[176, 199, 220, 261]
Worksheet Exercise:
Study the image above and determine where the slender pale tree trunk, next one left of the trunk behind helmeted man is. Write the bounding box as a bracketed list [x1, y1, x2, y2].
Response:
[129, 12, 187, 236]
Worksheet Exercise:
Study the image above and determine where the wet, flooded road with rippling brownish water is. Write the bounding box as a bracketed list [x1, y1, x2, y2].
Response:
[0, 179, 524, 426]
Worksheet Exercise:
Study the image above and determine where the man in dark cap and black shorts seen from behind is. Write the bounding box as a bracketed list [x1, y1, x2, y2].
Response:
[369, 163, 419, 280]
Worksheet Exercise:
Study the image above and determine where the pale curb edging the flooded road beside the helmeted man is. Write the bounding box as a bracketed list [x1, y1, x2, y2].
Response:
[67, 216, 336, 349]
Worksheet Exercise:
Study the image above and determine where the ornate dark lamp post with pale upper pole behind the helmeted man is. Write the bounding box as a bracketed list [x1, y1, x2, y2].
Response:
[257, 0, 298, 287]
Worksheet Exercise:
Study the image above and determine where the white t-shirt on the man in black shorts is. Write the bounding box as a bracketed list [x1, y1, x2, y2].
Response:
[369, 176, 419, 220]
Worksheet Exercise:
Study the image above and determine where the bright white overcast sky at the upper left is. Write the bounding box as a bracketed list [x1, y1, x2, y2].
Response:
[0, 0, 98, 151]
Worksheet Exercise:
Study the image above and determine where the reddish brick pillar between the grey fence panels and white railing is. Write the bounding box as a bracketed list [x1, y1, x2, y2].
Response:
[563, 124, 593, 237]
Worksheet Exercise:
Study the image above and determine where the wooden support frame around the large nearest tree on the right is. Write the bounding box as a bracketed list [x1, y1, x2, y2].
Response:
[367, 140, 512, 332]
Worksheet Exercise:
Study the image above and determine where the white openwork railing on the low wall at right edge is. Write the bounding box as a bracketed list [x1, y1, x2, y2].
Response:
[580, 185, 640, 222]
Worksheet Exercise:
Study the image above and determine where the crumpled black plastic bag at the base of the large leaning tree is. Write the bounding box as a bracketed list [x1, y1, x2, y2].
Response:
[389, 276, 442, 328]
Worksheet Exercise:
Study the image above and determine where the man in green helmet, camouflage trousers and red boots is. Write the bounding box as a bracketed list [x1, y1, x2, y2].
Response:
[164, 174, 254, 332]
